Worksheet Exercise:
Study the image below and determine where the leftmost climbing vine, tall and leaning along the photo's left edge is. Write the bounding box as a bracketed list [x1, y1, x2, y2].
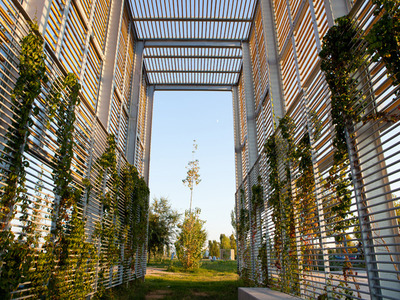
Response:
[0, 23, 47, 298]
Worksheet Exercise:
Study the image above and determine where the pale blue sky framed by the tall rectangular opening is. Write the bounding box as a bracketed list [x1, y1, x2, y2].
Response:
[149, 92, 236, 240]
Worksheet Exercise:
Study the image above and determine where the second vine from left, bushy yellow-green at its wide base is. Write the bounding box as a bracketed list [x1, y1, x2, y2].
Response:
[43, 73, 96, 299]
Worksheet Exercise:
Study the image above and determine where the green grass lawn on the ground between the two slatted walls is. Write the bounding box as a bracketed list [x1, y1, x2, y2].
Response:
[106, 261, 243, 300]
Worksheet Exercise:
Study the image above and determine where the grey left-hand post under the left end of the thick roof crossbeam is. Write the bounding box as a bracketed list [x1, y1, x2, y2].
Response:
[126, 42, 145, 165]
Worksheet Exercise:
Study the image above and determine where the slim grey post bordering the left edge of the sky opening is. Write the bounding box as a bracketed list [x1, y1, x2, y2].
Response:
[143, 85, 154, 185]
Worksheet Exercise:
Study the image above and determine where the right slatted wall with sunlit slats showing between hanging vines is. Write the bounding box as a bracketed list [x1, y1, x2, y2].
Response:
[236, 0, 400, 299]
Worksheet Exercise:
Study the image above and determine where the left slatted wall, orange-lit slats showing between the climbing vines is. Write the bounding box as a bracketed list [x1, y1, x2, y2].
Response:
[0, 0, 147, 299]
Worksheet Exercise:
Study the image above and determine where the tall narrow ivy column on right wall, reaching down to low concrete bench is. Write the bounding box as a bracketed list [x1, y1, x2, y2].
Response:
[264, 116, 299, 294]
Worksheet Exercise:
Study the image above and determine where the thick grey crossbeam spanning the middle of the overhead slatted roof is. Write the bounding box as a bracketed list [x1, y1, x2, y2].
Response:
[144, 39, 242, 48]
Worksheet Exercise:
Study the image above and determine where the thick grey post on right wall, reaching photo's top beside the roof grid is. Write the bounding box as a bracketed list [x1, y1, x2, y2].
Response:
[261, 0, 286, 124]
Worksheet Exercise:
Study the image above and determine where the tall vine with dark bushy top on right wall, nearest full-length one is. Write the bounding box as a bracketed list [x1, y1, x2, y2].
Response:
[319, 17, 362, 242]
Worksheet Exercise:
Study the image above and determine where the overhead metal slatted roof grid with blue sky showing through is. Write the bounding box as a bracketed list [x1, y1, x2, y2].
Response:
[130, 0, 257, 89]
